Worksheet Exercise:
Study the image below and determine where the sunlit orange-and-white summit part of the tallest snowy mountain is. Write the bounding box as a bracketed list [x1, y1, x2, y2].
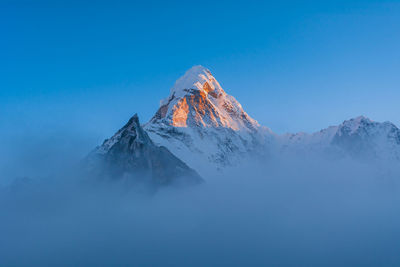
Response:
[150, 66, 260, 131]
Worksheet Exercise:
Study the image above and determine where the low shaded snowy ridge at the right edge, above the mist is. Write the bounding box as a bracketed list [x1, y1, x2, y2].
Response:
[279, 116, 400, 161]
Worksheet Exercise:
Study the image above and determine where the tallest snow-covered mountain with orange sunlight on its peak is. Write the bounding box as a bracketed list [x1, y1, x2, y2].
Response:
[144, 66, 271, 173]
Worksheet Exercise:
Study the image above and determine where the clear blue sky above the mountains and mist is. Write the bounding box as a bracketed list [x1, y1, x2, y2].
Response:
[0, 0, 400, 142]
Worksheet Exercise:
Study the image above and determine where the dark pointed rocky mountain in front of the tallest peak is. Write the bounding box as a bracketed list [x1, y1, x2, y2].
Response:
[88, 114, 202, 186]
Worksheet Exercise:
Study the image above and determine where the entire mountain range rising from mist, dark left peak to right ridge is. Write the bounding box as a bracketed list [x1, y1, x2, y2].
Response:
[89, 66, 400, 185]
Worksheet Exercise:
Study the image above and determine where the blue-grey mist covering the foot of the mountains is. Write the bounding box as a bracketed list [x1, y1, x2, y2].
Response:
[0, 136, 400, 266]
